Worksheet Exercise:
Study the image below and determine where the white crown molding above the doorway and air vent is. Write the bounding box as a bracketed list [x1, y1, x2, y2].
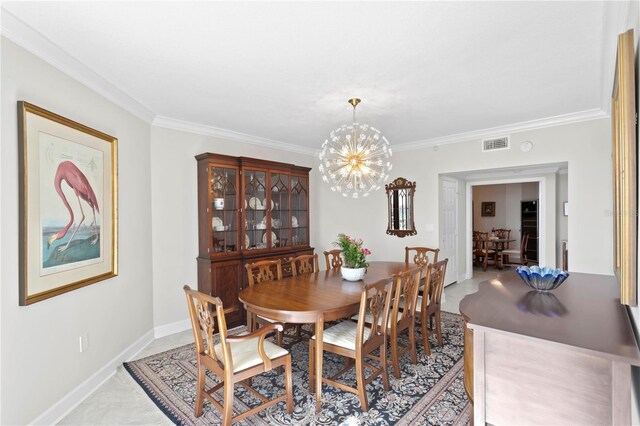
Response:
[391, 108, 609, 152]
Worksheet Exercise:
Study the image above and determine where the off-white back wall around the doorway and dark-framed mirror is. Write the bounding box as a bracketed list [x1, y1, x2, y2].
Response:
[314, 119, 613, 280]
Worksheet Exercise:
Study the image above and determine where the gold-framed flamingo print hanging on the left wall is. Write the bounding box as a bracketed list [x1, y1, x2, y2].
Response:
[18, 101, 118, 305]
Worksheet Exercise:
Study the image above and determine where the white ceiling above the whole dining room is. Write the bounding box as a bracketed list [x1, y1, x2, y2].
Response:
[2, 2, 610, 148]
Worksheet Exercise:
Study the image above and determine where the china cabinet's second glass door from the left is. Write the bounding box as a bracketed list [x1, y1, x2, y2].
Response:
[244, 170, 271, 250]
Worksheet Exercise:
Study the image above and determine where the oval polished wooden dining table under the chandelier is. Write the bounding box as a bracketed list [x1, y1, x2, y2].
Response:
[238, 262, 415, 411]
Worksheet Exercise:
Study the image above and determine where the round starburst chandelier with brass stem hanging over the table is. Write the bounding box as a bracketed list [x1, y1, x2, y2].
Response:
[319, 98, 392, 198]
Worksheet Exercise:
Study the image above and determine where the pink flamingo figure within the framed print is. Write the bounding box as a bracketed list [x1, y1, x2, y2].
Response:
[47, 161, 100, 251]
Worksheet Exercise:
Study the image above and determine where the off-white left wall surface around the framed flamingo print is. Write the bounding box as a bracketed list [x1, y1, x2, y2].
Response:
[0, 38, 152, 424]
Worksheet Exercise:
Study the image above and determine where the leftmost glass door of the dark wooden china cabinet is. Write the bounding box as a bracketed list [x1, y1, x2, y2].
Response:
[210, 166, 240, 254]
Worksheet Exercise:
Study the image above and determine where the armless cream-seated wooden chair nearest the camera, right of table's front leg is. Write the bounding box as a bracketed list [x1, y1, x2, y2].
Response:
[309, 277, 395, 411]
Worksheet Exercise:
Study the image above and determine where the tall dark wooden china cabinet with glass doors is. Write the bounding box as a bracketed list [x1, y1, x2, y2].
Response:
[196, 153, 313, 327]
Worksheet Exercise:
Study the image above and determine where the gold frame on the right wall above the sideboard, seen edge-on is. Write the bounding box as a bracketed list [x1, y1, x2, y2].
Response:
[611, 29, 638, 306]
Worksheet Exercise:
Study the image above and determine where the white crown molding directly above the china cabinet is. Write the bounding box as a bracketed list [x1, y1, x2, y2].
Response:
[151, 115, 316, 155]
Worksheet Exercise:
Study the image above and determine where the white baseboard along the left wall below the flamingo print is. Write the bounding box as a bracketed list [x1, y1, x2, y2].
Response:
[29, 330, 153, 425]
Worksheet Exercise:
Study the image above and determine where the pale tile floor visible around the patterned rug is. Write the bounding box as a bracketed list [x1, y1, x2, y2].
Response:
[59, 269, 496, 425]
